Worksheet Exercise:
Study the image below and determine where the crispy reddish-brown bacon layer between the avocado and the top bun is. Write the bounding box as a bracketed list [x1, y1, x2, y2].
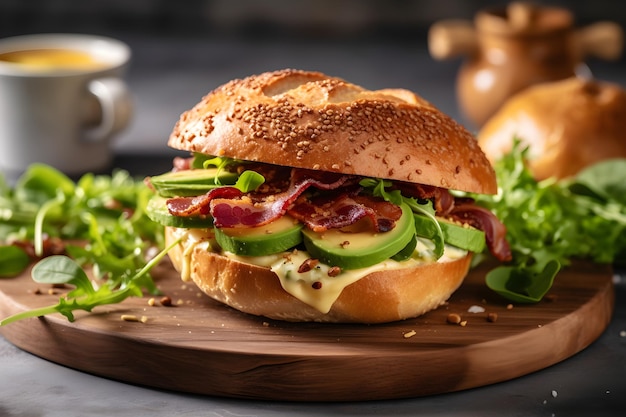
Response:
[167, 162, 512, 262]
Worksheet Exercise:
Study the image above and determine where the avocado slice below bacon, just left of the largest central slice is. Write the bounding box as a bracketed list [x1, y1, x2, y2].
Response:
[215, 215, 303, 256]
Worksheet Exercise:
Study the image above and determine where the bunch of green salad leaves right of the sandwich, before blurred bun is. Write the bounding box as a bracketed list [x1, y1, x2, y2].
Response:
[470, 139, 626, 302]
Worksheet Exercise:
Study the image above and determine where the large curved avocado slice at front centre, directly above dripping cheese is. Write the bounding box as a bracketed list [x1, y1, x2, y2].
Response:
[302, 204, 415, 269]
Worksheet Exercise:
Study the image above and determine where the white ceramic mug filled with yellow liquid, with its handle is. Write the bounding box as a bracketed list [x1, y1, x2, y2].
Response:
[0, 34, 132, 179]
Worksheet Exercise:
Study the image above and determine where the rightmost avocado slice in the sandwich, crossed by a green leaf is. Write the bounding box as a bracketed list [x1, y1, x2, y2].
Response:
[414, 214, 485, 253]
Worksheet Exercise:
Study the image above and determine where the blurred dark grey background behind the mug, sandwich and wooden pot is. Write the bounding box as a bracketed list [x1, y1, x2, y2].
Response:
[0, 0, 626, 155]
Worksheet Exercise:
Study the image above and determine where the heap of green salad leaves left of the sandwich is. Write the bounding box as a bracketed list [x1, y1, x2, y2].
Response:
[0, 164, 163, 325]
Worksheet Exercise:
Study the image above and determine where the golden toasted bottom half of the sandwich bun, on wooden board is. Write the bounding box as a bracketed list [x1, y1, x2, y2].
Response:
[165, 227, 472, 323]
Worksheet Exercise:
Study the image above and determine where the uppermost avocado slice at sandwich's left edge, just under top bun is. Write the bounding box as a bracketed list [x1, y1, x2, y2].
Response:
[150, 168, 238, 197]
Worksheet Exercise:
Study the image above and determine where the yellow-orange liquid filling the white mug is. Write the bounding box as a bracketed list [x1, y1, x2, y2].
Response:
[0, 49, 106, 71]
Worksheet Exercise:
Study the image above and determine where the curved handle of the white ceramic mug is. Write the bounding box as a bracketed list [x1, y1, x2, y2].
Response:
[86, 77, 133, 142]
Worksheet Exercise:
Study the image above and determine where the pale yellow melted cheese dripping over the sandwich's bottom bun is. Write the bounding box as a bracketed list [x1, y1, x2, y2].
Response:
[169, 229, 467, 313]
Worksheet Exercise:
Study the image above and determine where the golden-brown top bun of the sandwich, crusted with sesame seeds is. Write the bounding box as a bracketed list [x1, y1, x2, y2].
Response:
[168, 69, 497, 194]
